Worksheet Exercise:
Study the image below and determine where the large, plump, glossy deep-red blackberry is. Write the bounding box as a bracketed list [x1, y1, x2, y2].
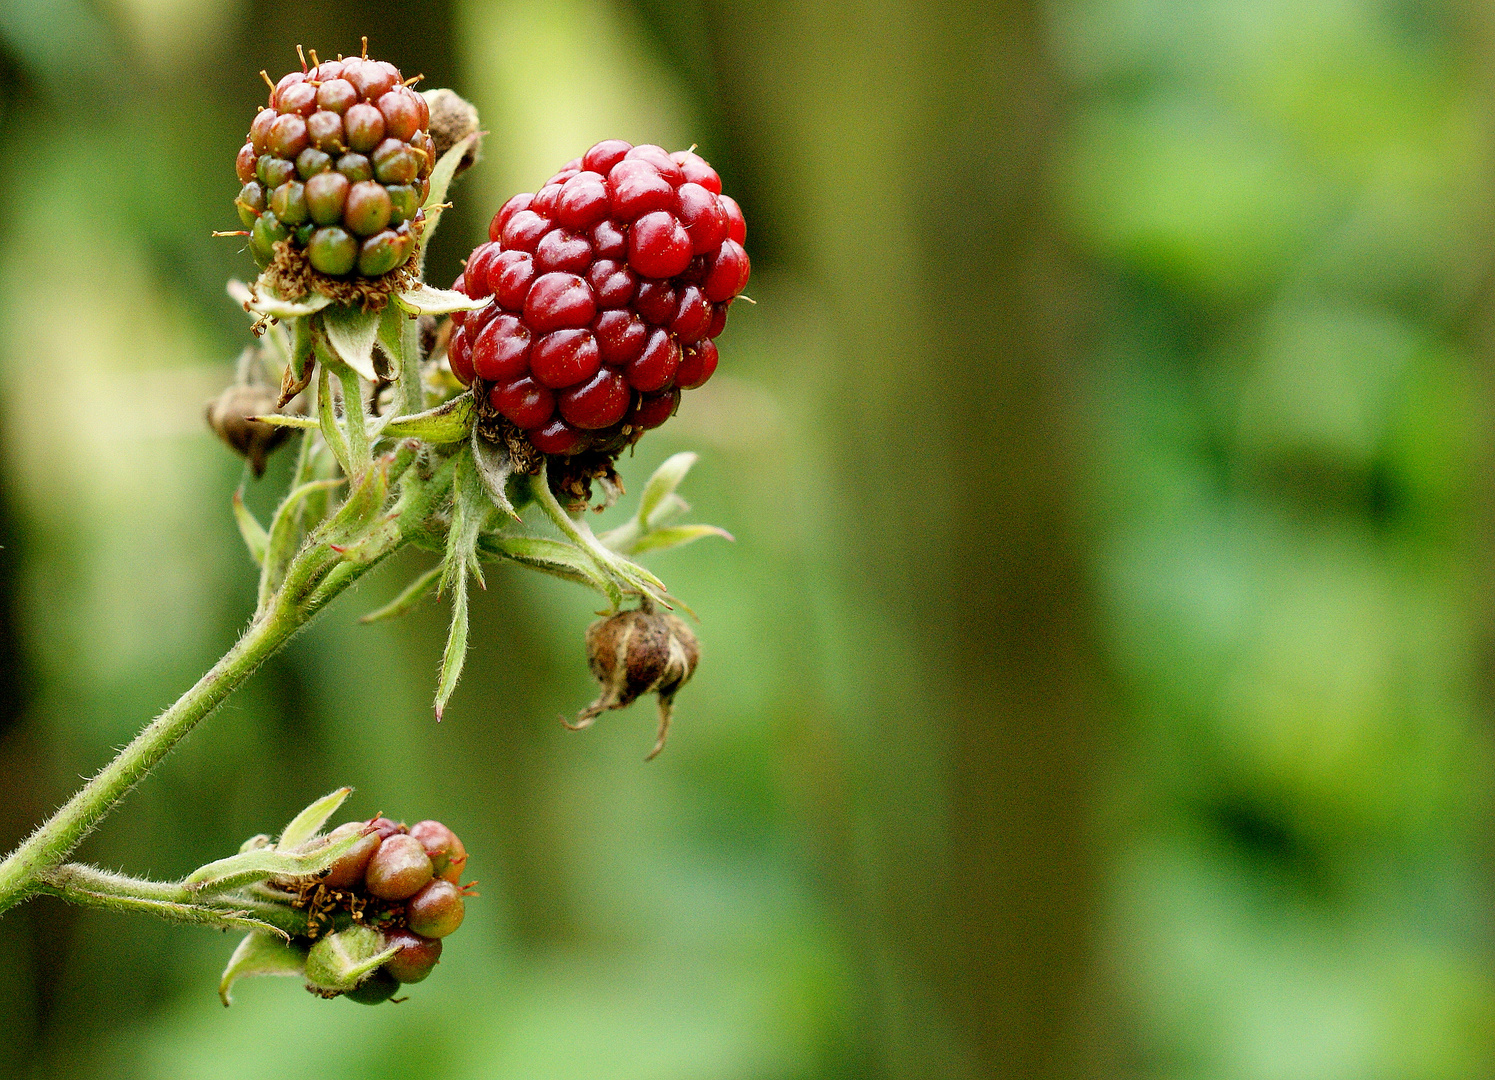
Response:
[447, 139, 750, 455]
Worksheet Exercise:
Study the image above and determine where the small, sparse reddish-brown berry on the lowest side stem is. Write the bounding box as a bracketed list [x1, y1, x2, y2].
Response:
[298, 817, 471, 1004]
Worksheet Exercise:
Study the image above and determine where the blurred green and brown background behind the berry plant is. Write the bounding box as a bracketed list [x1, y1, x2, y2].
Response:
[0, 0, 1495, 1080]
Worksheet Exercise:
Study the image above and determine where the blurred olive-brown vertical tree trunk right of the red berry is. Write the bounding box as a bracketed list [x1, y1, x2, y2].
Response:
[709, 0, 1096, 1080]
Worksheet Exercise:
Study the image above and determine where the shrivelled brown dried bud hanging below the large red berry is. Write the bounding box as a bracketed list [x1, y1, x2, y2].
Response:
[567, 607, 701, 761]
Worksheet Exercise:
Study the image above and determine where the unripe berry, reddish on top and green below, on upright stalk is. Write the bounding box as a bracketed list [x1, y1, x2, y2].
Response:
[236, 54, 435, 277]
